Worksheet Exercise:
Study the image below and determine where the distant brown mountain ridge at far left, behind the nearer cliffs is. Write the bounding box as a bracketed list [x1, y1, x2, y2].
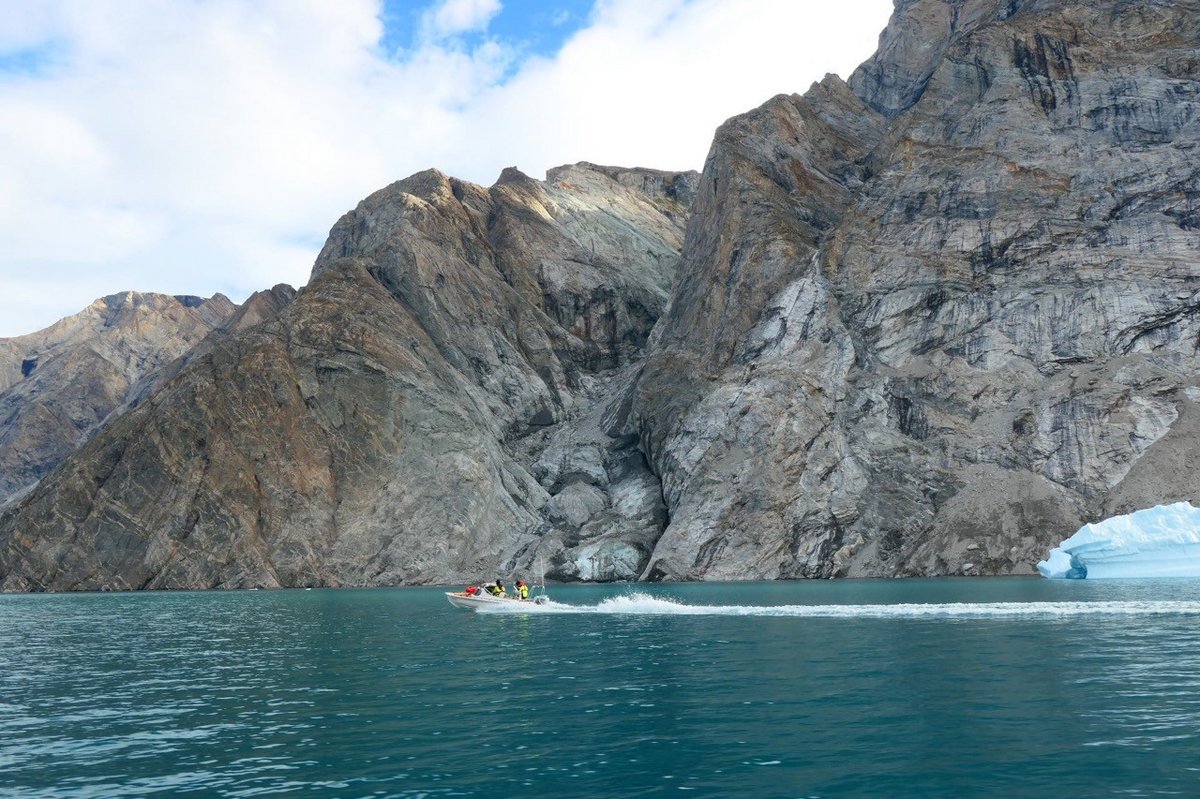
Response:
[0, 292, 236, 505]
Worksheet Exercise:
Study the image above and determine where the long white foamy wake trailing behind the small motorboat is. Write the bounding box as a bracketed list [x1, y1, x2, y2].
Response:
[479, 594, 1200, 619]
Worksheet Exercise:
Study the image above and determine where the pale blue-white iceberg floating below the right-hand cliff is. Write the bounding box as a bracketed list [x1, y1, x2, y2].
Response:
[1038, 503, 1200, 579]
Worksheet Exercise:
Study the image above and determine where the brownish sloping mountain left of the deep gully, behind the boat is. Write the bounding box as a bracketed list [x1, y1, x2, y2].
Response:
[0, 164, 698, 590]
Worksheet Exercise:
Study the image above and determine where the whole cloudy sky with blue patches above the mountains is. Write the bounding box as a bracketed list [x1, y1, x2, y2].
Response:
[0, 0, 892, 337]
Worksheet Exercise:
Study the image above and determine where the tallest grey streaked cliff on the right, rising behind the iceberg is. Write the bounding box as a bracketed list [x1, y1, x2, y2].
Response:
[634, 0, 1200, 579]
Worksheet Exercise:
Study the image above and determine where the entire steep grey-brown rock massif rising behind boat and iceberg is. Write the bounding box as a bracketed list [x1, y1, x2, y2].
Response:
[0, 0, 1200, 590]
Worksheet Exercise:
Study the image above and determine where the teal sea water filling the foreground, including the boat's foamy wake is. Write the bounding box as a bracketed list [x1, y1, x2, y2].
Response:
[0, 579, 1200, 798]
